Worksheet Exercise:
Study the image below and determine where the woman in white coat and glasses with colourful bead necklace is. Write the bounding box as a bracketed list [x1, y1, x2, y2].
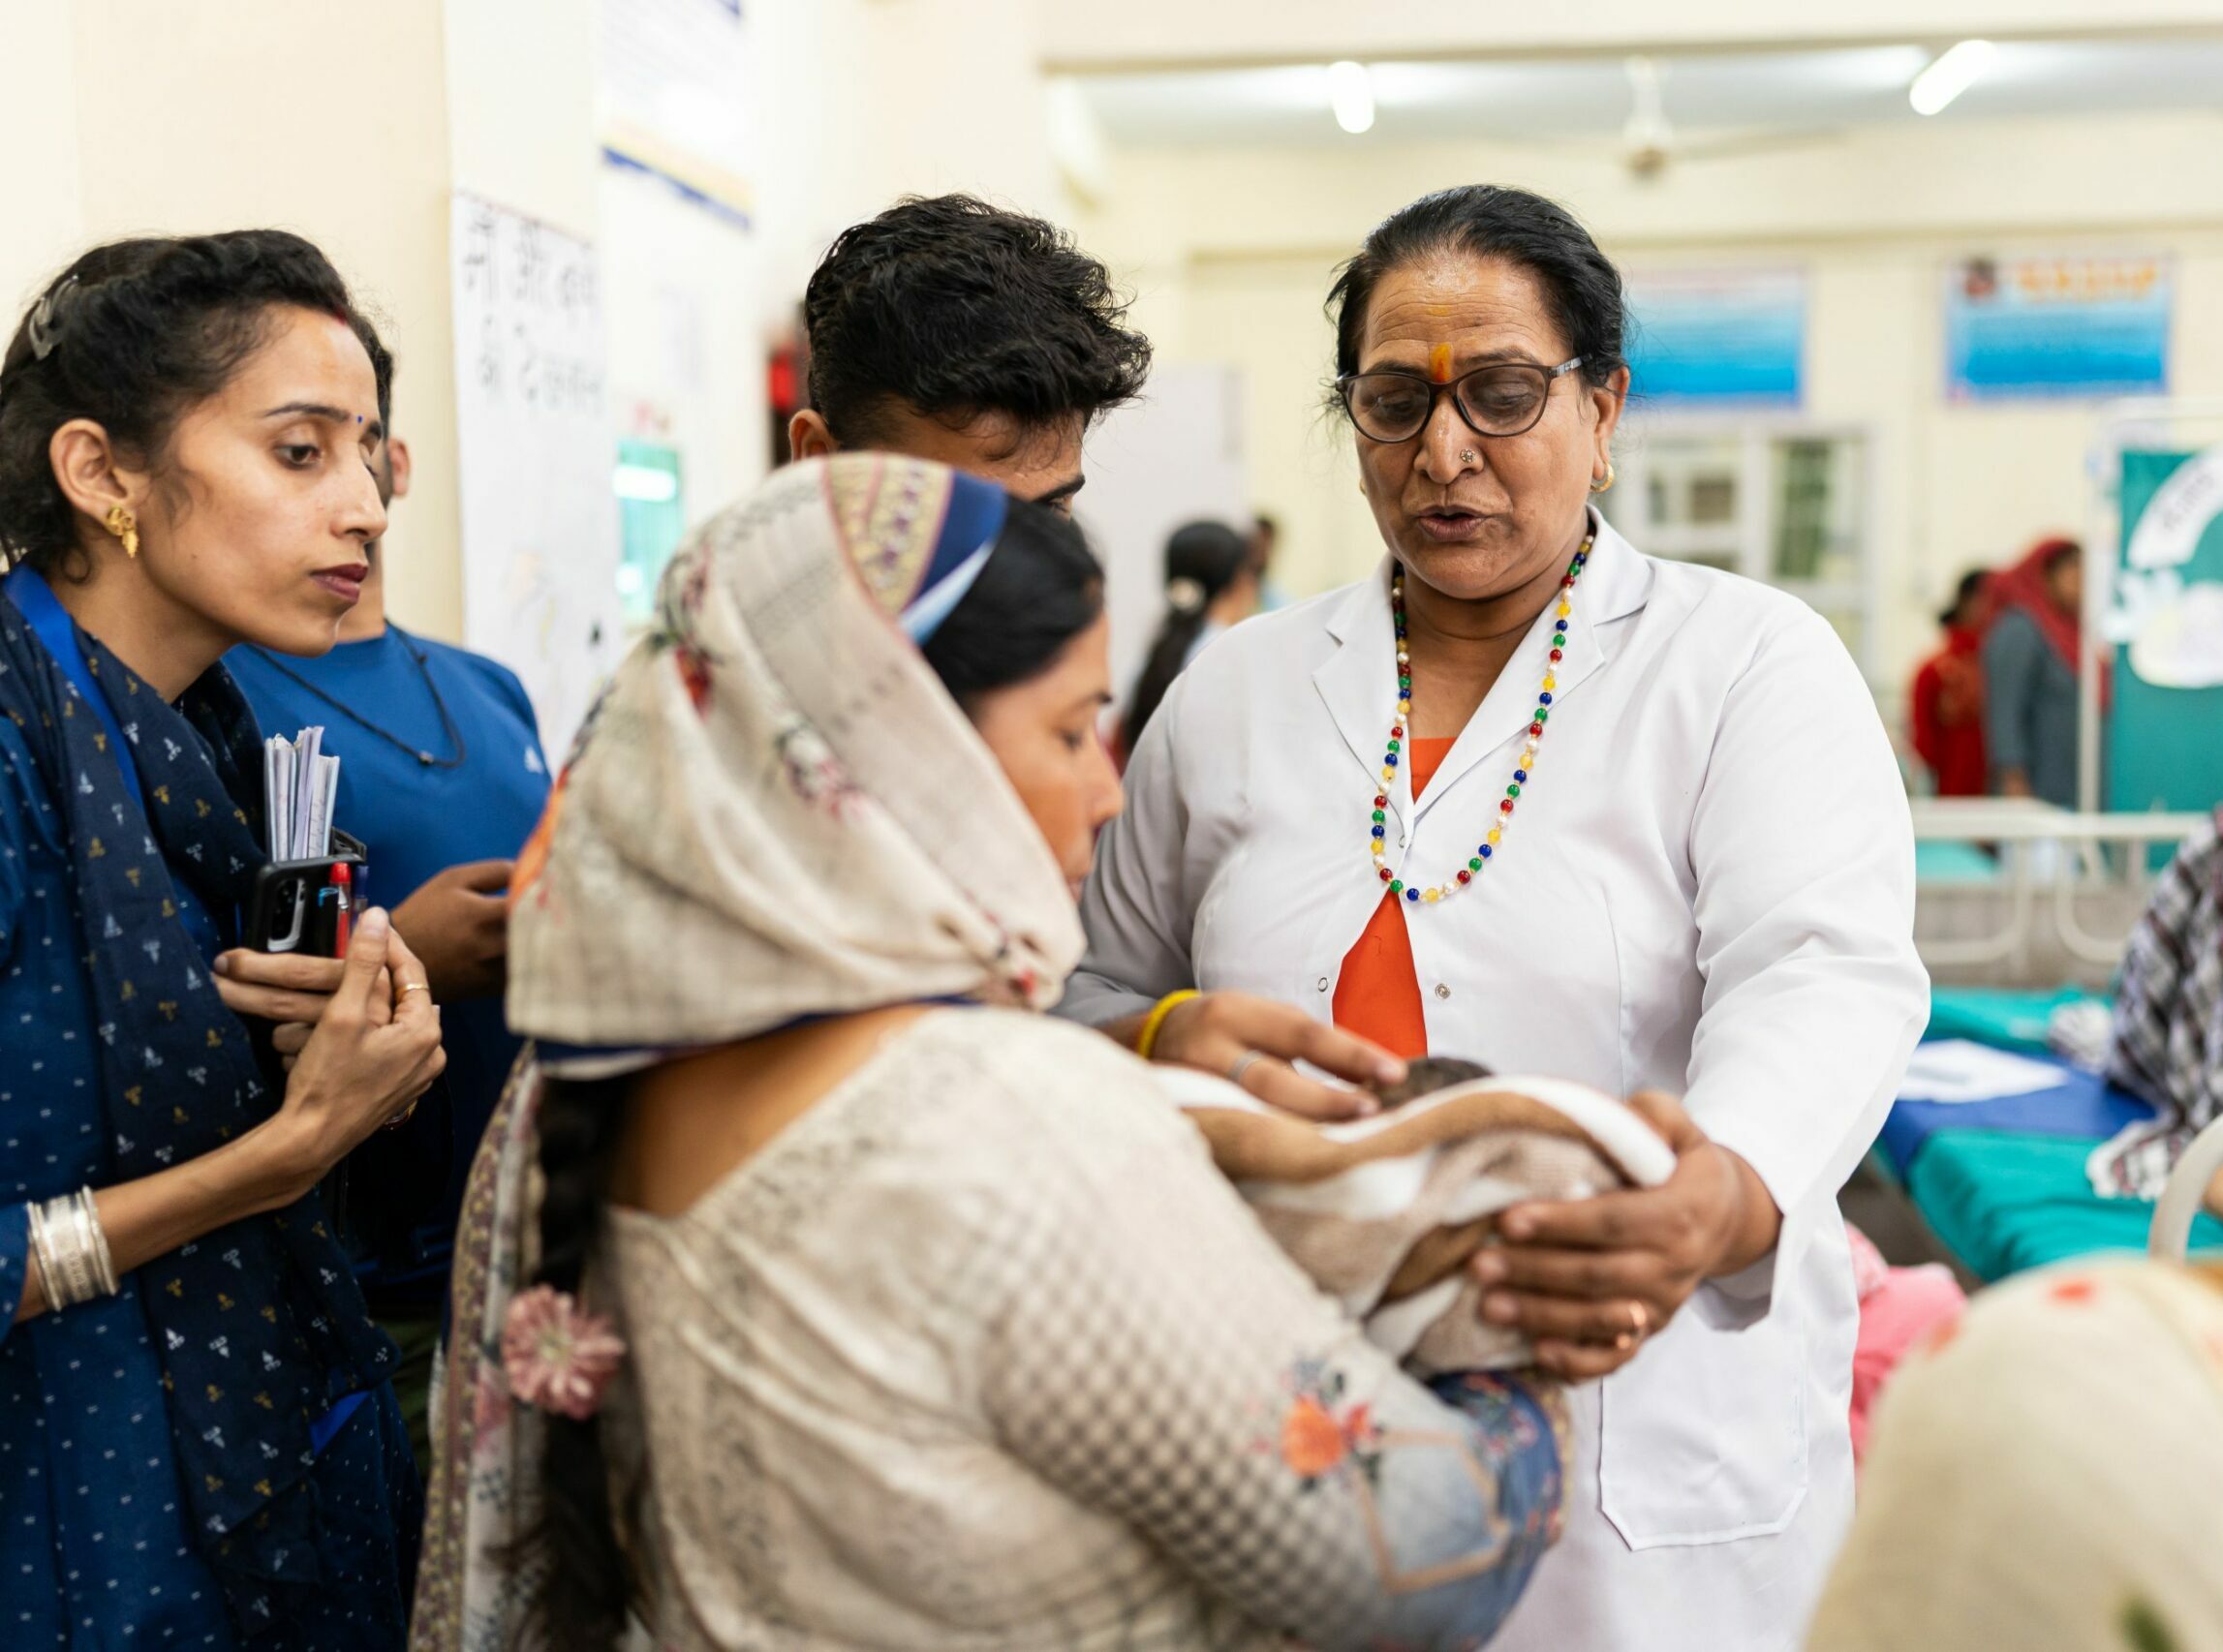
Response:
[1067, 187, 1928, 1652]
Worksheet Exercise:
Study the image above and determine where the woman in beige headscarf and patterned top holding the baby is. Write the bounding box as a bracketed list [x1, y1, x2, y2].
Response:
[414, 453, 1583, 1652]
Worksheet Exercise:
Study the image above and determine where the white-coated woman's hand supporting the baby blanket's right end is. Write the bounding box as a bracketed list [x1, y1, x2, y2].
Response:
[1471, 1094, 1783, 1381]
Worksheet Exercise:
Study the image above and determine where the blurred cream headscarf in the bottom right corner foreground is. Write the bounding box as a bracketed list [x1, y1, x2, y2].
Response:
[1807, 1256, 2223, 1652]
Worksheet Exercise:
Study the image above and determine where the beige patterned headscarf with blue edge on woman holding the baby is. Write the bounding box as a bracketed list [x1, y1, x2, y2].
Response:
[509, 453, 1083, 1050]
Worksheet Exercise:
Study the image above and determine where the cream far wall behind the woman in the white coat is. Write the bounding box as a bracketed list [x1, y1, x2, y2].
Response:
[1083, 115, 2223, 696]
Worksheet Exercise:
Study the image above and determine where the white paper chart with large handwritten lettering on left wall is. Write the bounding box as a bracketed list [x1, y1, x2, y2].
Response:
[451, 194, 625, 753]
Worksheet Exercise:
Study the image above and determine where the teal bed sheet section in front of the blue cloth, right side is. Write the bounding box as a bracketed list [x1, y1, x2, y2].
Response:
[1907, 1129, 2223, 1283]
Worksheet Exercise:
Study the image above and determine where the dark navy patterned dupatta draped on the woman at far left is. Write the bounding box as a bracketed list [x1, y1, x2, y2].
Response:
[0, 569, 396, 1638]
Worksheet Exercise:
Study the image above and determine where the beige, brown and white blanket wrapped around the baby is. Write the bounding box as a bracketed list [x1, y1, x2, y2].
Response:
[1158, 1058, 1674, 1374]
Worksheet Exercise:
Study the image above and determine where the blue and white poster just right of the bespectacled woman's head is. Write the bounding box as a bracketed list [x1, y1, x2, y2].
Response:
[1627, 269, 1807, 409]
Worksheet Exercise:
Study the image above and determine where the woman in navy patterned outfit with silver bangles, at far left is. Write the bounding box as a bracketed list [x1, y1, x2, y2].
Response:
[0, 231, 440, 1652]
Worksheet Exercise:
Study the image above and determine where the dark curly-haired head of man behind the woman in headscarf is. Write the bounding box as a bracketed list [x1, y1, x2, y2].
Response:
[787, 196, 1150, 511]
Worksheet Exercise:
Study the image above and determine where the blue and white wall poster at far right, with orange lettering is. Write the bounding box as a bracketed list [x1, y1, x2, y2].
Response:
[1945, 256, 2170, 403]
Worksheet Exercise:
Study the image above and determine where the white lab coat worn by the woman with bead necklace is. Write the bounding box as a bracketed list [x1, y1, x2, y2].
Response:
[1061, 525, 1930, 1652]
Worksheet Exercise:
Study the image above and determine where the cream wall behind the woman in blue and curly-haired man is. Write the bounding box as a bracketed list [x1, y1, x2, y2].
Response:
[0, 0, 1063, 636]
